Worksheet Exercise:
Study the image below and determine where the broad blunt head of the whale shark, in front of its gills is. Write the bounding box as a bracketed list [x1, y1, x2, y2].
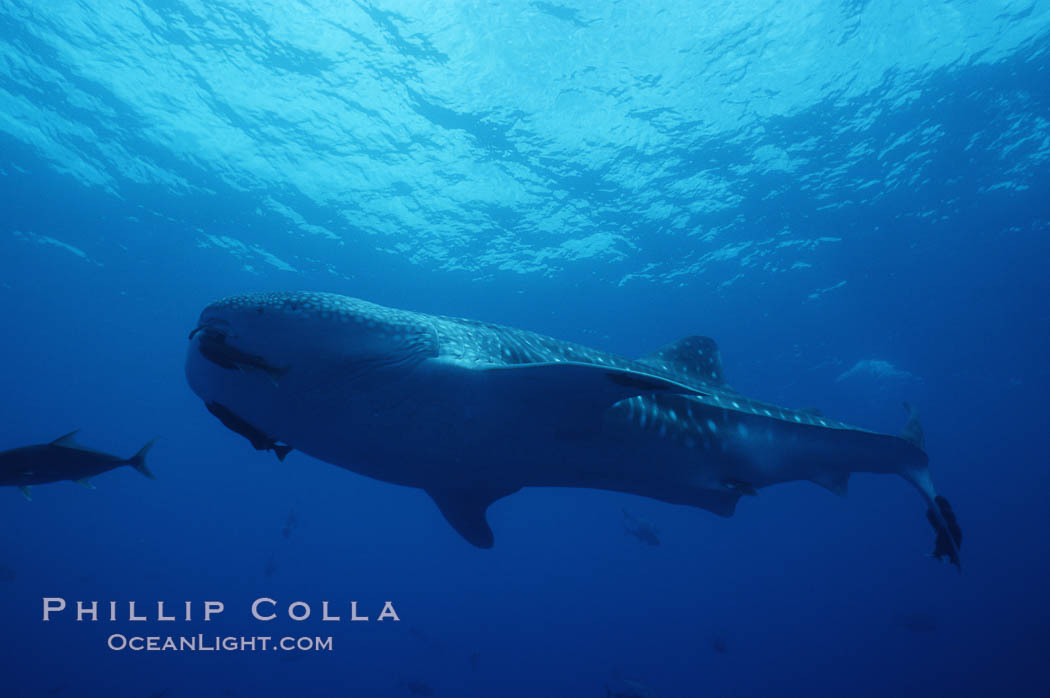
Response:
[186, 293, 437, 415]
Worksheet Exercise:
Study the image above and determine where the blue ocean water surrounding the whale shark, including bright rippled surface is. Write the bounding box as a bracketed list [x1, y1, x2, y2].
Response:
[0, 0, 1050, 698]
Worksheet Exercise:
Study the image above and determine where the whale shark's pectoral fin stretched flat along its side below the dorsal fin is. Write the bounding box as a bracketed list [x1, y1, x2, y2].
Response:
[482, 361, 707, 409]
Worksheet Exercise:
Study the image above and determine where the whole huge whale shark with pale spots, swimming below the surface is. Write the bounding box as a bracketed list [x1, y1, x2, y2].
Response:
[186, 293, 961, 565]
